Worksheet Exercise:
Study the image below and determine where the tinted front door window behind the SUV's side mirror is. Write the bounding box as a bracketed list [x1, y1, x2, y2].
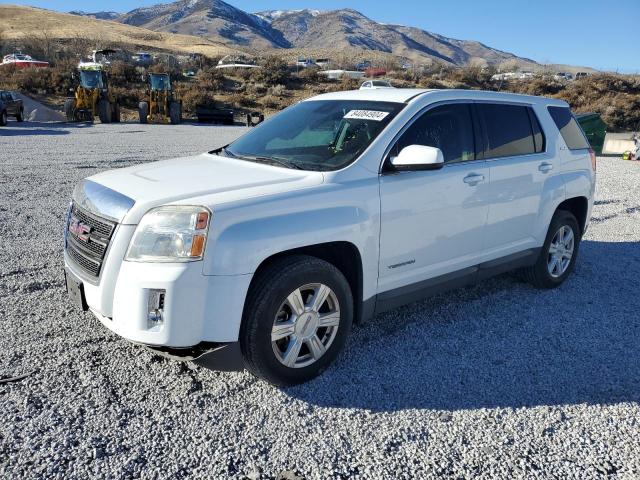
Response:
[391, 103, 476, 163]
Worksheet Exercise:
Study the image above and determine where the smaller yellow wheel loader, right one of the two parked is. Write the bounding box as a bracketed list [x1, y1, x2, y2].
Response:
[138, 73, 182, 125]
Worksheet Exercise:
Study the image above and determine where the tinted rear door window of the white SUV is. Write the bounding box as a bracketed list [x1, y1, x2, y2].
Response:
[476, 103, 544, 159]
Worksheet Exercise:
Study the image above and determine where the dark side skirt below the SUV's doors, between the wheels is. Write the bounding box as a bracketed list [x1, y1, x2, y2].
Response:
[363, 248, 541, 320]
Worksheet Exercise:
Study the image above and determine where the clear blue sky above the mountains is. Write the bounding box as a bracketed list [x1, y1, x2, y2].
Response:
[11, 0, 640, 73]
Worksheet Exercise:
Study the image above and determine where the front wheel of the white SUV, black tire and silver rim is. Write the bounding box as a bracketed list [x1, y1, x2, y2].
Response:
[240, 255, 353, 387]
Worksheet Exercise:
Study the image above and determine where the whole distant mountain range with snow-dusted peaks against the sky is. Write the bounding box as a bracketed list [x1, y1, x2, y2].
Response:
[115, 0, 535, 65]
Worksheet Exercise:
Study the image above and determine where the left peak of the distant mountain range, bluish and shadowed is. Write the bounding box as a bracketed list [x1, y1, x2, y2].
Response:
[118, 0, 291, 48]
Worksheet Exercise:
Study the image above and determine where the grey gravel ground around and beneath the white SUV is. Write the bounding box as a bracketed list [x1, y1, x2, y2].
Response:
[0, 122, 640, 479]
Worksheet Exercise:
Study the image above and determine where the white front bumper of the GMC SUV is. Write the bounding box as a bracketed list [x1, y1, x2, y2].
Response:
[65, 255, 251, 348]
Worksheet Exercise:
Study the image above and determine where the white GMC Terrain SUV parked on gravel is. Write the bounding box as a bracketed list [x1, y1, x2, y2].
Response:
[64, 89, 596, 385]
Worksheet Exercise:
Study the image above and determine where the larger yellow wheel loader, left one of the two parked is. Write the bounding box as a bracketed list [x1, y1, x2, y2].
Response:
[64, 62, 120, 123]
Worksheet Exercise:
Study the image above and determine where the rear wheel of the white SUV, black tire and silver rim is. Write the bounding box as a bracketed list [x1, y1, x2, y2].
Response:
[521, 210, 582, 289]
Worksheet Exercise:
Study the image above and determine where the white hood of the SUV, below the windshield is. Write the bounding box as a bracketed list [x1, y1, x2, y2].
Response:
[80, 153, 324, 224]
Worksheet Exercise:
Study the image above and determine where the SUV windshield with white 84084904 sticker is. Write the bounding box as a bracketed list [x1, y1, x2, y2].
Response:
[224, 100, 404, 171]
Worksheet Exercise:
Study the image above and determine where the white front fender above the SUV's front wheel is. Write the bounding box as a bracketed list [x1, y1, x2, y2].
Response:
[203, 177, 380, 299]
